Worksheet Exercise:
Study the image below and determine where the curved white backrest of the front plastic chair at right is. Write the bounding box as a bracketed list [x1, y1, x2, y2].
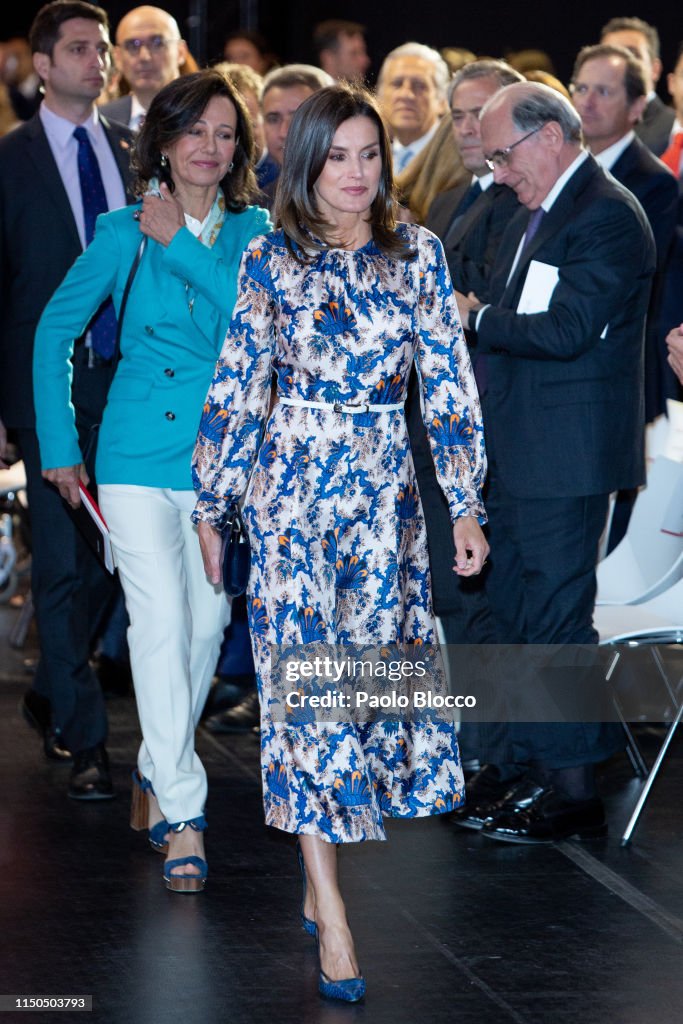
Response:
[596, 457, 683, 605]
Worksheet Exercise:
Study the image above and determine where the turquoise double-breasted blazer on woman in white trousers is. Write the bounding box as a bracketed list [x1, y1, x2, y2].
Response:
[34, 206, 270, 490]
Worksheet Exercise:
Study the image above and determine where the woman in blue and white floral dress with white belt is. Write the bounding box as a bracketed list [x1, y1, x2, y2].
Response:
[194, 86, 487, 998]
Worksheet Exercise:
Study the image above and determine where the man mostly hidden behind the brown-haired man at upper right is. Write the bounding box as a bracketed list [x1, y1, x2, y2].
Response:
[600, 17, 674, 157]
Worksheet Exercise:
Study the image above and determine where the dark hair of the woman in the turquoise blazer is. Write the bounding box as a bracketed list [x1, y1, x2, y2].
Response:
[132, 68, 256, 212]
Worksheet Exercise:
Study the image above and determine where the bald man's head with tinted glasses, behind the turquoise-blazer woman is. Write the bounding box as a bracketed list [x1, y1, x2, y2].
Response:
[114, 6, 187, 110]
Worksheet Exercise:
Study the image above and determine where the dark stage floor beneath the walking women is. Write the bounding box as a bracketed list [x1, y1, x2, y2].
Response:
[0, 606, 683, 1024]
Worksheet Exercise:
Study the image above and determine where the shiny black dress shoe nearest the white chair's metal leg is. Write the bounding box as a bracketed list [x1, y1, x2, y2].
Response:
[481, 788, 607, 845]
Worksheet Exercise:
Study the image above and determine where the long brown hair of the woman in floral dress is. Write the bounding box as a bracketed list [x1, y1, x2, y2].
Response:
[275, 82, 415, 259]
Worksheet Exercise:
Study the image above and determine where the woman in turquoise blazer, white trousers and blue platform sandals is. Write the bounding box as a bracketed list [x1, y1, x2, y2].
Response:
[35, 71, 270, 892]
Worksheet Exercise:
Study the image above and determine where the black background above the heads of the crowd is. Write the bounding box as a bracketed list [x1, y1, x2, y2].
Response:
[0, 0, 683, 96]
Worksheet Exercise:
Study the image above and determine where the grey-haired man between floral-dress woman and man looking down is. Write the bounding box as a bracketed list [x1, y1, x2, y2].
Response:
[407, 59, 523, 782]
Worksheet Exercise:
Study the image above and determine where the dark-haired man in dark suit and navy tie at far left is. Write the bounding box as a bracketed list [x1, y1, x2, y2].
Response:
[0, 0, 132, 800]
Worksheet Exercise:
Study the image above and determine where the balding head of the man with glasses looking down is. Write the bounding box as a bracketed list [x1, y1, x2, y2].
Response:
[481, 82, 582, 210]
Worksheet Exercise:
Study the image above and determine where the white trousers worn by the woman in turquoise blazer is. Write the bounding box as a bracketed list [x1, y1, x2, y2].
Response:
[98, 483, 230, 824]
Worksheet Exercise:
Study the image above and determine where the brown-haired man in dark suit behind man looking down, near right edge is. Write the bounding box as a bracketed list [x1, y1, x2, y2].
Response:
[571, 43, 678, 422]
